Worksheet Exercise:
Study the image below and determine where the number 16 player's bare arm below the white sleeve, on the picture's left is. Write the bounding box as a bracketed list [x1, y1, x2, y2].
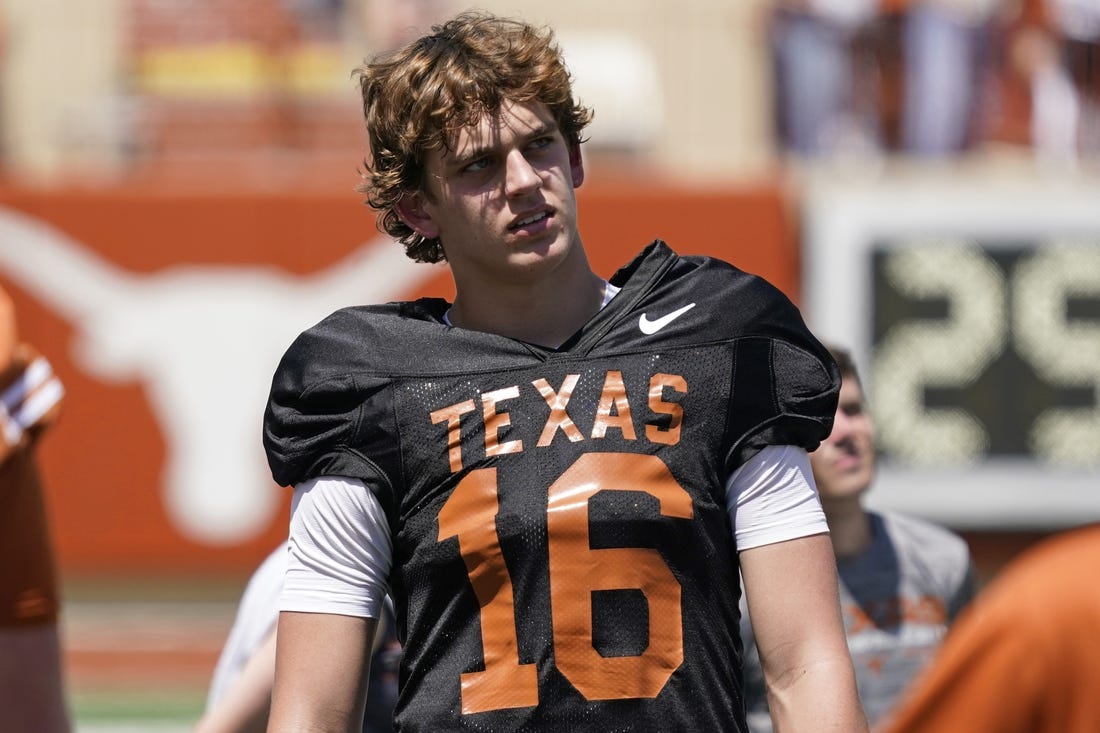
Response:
[267, 611, 376, 733]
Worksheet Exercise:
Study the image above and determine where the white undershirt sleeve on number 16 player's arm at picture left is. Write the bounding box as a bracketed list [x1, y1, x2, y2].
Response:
[279, 477, 393, 619]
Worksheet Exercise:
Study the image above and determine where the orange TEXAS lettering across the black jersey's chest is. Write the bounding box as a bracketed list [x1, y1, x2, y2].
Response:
[429, 370, 688, 472]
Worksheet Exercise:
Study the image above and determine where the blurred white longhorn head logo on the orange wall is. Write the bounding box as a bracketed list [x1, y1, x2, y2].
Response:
[0, 208, 437, 544]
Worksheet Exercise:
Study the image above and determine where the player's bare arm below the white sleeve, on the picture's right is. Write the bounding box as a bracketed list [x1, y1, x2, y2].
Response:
[740, 534, 868, 733]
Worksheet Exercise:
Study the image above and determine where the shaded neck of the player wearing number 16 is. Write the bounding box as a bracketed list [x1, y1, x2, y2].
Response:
[449, 259, 606, 348]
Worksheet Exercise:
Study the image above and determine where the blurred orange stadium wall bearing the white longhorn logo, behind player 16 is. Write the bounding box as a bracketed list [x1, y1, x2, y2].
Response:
[0, 184, 800, 579]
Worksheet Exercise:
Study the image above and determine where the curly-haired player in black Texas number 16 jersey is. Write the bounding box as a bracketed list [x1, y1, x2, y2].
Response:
[264, 13, 866, 732]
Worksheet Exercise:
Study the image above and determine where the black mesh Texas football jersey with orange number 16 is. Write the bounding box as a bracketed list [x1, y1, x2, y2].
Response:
[264, 241, 839, 733]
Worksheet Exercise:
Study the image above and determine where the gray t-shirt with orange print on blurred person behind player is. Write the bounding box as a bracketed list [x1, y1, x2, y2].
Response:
[741, 513, 976, 733]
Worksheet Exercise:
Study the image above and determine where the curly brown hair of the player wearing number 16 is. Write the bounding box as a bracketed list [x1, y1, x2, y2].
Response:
[355, 12, 592, 262]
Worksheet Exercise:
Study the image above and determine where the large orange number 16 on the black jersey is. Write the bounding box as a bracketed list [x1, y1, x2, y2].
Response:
[439, 453, 693, 714]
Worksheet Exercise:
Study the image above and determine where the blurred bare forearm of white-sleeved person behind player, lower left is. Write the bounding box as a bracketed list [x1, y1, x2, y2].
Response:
[195, 628, 275, 733]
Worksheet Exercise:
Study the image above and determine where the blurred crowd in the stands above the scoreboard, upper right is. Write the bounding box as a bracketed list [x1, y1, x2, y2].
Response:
[768, 0, 1100, 162]
